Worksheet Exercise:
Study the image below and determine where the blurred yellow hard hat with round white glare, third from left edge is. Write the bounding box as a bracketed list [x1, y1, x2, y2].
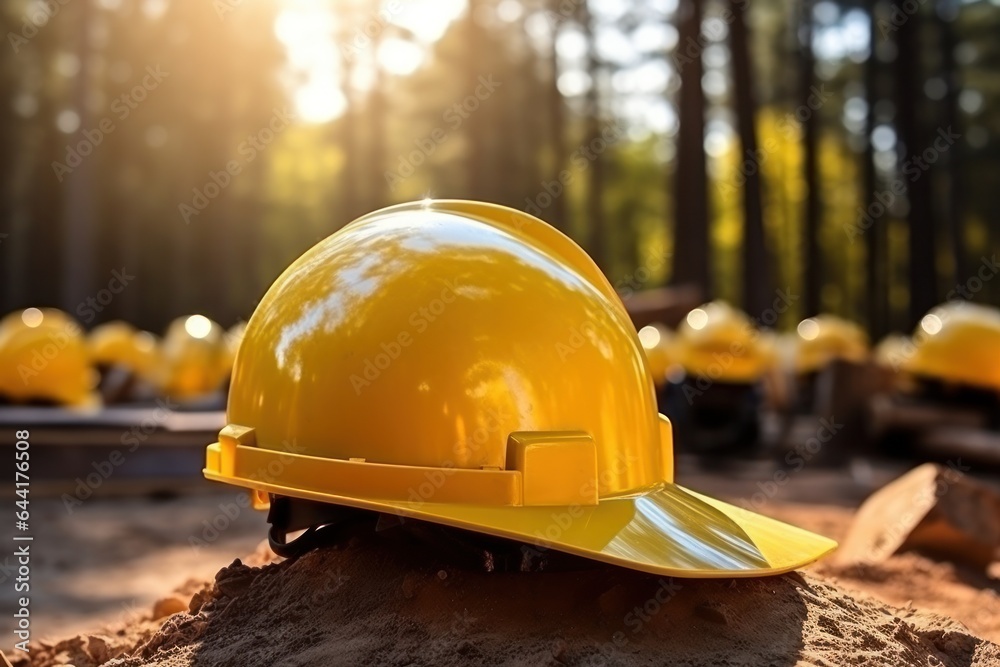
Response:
[159, 315, 231, 399]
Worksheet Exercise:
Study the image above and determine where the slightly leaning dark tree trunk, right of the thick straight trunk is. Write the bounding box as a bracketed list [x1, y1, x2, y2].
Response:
[729, 0, 772, 317]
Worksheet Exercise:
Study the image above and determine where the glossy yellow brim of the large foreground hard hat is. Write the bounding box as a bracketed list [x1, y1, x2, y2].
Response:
[204, 468, 837, 578]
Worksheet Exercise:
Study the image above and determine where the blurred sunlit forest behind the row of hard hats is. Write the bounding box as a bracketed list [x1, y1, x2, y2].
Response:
[0, 0, 1000, 337]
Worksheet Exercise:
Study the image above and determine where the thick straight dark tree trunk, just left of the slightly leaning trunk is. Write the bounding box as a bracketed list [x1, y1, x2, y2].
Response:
[671, 0, 712, 296]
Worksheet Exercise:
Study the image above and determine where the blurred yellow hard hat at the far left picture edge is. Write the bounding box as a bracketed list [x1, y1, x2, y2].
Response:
[0, 308, 99, 407]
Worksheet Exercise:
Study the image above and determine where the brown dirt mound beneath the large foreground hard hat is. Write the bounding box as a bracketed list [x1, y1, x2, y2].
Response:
[11, 535, 1000, 667]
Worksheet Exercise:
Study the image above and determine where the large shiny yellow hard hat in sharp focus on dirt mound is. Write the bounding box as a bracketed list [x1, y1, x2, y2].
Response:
[204, 201, 836, 577]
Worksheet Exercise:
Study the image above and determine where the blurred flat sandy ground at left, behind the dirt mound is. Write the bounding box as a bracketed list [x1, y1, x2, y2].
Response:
[0, 484, 267, 640]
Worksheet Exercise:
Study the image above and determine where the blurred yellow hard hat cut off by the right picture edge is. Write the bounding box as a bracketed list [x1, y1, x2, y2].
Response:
[902, 301, 1000, 390]
